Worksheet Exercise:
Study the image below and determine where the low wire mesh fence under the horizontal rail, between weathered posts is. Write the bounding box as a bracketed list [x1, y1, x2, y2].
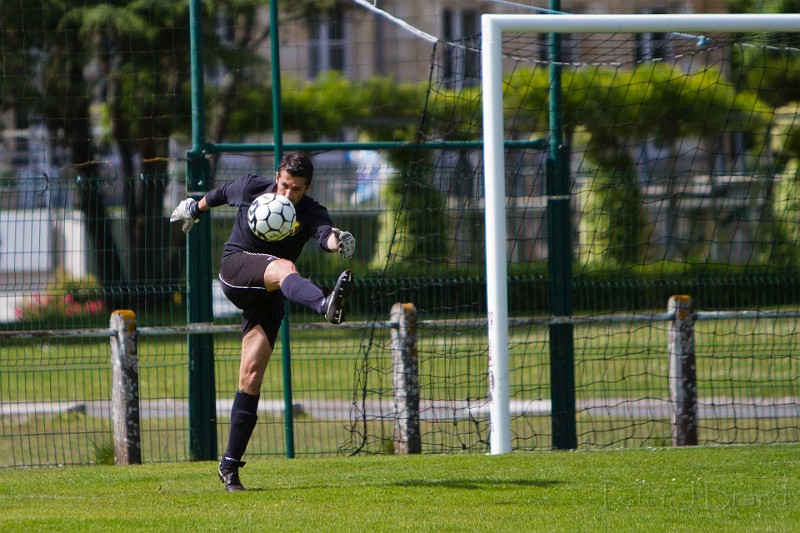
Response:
[0, 283, 800, 466]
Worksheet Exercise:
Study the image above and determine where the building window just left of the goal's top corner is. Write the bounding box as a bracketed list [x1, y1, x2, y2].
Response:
[442, 9, 481, 87]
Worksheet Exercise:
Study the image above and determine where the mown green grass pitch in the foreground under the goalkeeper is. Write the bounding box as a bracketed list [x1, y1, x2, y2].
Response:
[0, 445, 800, 532]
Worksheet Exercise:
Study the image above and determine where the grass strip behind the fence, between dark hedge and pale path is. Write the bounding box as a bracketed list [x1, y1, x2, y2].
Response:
[0, 319, 800, 402]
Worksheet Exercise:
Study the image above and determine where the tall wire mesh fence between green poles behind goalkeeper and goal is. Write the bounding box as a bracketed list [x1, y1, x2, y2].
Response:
[0, 2, 800, 466]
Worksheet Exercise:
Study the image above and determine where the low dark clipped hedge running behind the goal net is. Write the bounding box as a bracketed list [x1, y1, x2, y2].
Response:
[351, 269, 800, 316]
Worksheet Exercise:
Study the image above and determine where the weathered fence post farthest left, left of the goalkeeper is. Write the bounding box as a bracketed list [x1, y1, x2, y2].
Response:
[111, 310, 142, 465]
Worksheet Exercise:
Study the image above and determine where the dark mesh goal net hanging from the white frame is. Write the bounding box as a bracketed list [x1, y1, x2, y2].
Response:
[342, 15, 800, 452]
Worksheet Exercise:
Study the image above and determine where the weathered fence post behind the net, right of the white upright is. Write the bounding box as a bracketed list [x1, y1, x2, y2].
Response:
[668, 295, 697, 446]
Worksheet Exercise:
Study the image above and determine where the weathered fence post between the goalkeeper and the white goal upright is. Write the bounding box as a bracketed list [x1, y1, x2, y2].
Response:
[392, 303, 422, 454]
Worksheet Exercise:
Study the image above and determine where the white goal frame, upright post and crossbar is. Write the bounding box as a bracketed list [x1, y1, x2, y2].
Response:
[481, 14, 800, 455]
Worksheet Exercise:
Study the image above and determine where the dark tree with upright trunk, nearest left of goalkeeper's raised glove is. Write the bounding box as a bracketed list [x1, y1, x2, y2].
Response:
[72, 0, 197, 309]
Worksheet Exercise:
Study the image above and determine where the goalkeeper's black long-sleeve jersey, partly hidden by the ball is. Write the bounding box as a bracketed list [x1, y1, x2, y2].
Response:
[206, 174, 333, 262]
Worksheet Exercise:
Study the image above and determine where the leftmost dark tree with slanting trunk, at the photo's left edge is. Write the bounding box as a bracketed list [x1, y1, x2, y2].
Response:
[0, 0, 126, 305]
